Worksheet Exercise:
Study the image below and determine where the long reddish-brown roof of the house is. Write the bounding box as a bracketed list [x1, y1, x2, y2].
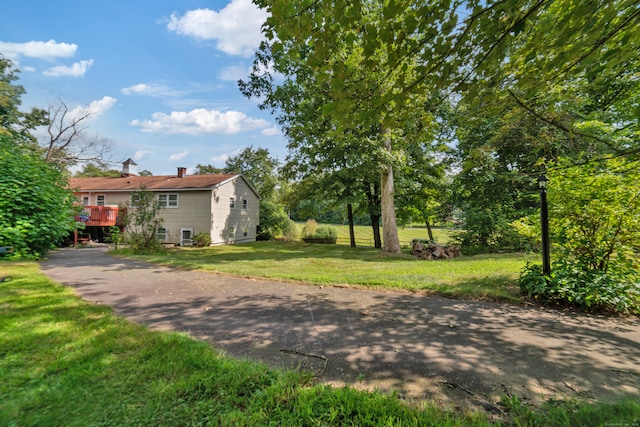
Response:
[69, 174, 240, 192]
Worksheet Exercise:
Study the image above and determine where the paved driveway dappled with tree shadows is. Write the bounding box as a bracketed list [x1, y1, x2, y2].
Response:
[42, 248, 640, 412]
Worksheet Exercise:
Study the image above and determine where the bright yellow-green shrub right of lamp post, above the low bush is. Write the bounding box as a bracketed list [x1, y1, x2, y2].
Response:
[548, 158, 640, 275]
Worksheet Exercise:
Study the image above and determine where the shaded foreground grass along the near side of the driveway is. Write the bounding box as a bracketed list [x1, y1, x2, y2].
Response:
[0, 262, 640, 426]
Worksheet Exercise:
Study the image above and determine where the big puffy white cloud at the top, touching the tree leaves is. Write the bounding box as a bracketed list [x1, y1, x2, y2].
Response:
[167, 0, 267, 56]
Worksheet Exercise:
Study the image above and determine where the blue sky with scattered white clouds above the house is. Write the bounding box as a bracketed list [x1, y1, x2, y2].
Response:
[0, 0, 286, 175]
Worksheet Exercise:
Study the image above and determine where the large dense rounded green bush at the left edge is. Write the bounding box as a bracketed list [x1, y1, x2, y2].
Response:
[0, 134, 74, 258]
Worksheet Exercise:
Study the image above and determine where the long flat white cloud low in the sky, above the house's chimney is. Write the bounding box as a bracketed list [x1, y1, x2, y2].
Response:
[129, 108, 269, 135]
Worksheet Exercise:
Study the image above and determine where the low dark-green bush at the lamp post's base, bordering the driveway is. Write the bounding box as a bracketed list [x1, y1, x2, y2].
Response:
[520, 260, 640, 314]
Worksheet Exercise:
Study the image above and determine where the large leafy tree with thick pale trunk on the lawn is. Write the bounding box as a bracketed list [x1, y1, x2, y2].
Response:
[241, 5, 438, 252]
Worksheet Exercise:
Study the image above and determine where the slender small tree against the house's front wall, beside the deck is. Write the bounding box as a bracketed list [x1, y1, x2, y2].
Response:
[125, 187, 164, 253]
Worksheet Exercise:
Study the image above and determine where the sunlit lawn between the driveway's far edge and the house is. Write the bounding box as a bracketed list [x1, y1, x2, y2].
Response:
[120, 242, 535, 302]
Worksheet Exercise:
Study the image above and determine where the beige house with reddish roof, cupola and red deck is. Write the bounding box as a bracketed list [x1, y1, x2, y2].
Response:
[69, 159, 260, 246]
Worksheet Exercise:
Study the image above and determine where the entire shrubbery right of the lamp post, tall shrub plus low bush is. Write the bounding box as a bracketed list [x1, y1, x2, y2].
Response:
[520, 159, 640, 313]
